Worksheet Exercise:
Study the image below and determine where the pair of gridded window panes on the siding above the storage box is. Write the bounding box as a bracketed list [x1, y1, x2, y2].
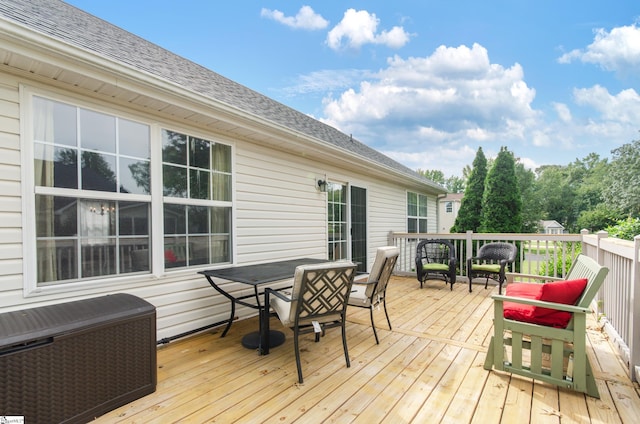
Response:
[28, 95, 232, 286]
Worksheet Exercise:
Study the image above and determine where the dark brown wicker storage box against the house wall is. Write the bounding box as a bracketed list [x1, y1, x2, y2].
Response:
[0, 294, 156, 424]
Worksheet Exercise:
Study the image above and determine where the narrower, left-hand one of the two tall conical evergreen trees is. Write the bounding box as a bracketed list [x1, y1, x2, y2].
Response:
[451, 147, 487, 233]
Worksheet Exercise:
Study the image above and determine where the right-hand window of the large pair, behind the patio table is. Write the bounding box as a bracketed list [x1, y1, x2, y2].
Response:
[162, 129, 231, 268]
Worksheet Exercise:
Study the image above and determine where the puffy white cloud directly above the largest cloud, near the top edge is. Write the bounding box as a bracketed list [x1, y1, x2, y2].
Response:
[327, 9, 409, 50]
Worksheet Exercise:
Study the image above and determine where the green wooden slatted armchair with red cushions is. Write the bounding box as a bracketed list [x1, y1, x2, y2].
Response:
[484, 255, 609, 398]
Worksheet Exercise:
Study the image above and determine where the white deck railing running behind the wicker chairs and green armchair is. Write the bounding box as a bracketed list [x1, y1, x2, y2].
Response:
[389, 230, 640, 381]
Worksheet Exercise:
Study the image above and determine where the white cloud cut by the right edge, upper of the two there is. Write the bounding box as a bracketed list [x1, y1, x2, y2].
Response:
[558, 24, 640, 75]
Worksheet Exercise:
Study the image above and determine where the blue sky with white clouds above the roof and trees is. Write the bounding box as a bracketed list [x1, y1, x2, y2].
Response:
[68, 0, 640, 176]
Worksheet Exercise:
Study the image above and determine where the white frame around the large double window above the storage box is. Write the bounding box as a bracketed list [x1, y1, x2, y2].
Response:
[19, 84, 236, 297]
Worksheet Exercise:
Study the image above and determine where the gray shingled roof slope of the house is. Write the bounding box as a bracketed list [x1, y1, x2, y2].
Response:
[0, 0, 440, 188]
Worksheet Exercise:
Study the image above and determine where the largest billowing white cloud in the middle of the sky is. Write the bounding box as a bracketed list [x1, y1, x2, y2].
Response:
[324, 44, 538, 142]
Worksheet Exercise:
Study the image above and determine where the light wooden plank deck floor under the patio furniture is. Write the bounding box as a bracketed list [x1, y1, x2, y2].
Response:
[95, 277, 640, 424]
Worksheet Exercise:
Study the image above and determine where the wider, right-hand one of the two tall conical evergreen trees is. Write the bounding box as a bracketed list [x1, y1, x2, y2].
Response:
[481, 147, 522, 233]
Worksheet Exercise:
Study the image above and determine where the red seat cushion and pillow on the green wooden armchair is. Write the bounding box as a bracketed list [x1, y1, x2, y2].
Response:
[504, 278, 587, 328]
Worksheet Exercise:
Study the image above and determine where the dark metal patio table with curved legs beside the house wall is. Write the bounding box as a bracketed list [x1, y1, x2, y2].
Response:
[198, 258, 327, 354]
